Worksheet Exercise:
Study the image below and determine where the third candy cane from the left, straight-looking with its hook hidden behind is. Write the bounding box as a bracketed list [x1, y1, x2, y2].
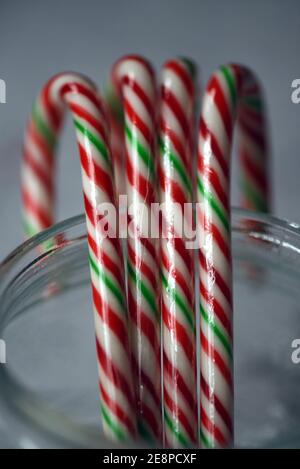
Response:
[159, 58, 198, 448]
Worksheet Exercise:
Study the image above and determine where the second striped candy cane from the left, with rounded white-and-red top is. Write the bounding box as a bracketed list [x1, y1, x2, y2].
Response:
[111, 55, 162, 439]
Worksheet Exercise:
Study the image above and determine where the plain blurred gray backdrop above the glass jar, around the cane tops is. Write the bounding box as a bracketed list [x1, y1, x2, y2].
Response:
[0, 0, 300, 259]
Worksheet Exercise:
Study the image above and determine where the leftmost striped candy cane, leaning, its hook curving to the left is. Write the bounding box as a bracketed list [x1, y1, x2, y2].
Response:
[22, 73, 136, 440]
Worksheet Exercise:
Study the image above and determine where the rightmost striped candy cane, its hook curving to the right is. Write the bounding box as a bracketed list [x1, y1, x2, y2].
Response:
[197, 65, 270, 448]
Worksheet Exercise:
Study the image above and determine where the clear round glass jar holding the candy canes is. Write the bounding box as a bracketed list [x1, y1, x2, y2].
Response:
[0, 209, 300, 448]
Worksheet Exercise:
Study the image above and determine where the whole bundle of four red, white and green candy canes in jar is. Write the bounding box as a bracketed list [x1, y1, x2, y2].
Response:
[22, 55, 271, 448]
